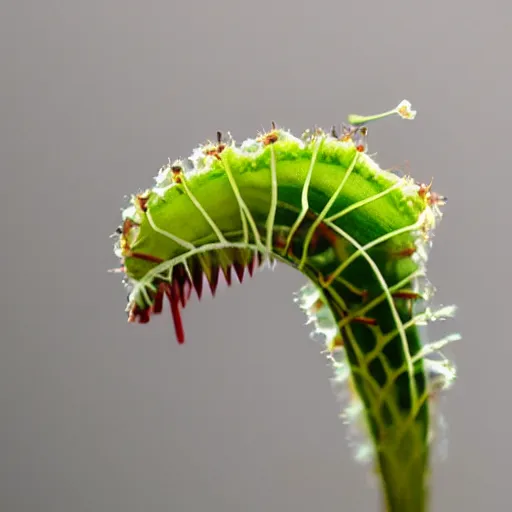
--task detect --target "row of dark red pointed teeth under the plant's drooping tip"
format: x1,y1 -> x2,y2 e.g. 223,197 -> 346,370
128,249 -> 264,344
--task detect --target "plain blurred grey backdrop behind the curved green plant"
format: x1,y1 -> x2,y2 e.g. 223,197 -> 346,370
0,0 -> 512,512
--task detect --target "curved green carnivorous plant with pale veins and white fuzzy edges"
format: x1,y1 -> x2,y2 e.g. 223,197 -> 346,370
111,100 -> 457,512
